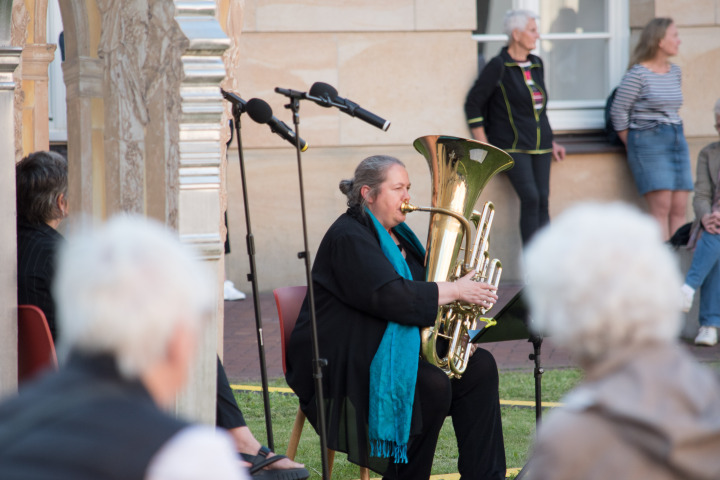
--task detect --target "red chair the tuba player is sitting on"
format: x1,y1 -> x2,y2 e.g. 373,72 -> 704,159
273,286 -> 370,480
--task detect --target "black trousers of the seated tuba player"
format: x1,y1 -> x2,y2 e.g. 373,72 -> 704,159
383,348 -> 506,480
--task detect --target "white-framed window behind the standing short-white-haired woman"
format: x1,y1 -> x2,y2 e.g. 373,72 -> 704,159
473,0 -> 630,132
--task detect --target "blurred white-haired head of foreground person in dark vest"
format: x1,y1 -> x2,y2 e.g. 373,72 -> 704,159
53,215 -> 215,379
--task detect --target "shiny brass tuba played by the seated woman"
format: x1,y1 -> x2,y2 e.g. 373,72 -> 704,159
402,135 -> 514,378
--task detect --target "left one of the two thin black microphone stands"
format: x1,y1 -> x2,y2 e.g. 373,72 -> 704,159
232,102 -> 275,451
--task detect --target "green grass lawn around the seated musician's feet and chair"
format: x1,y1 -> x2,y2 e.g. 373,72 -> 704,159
235,369 -> 581,480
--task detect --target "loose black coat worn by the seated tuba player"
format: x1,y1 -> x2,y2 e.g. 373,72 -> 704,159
286,209 -> 438,471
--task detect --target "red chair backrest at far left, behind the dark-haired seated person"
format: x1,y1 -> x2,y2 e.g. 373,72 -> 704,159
18,305 -> 57,383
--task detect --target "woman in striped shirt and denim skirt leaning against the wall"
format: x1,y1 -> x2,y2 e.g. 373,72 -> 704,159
611,18 -> 693,240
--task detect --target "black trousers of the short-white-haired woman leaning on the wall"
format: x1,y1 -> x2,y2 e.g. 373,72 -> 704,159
506,153 -> 552,245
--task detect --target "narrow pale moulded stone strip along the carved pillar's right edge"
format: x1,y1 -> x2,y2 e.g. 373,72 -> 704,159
175,0 -> 229,423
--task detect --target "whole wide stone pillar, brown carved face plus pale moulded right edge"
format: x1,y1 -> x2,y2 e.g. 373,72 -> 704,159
58,0 -> 227,423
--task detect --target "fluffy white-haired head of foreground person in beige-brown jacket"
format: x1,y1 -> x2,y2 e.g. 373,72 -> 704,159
525,203 -> 682,367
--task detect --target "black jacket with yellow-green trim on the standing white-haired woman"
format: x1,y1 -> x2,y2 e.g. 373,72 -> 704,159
465,47 -> 553,154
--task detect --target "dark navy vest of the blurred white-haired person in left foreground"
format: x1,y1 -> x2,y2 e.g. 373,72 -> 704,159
0,354 -> 188,480
